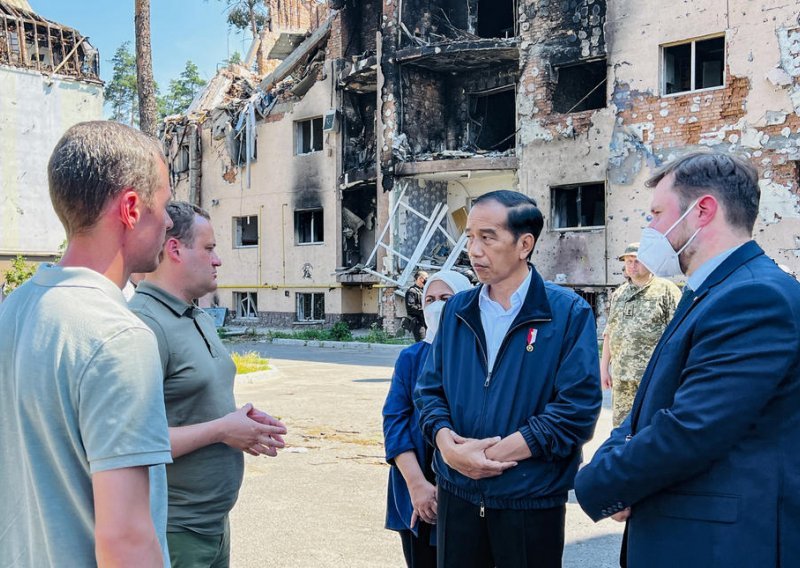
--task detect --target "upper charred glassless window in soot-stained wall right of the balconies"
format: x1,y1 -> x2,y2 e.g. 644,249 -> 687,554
553,59 -> 608,113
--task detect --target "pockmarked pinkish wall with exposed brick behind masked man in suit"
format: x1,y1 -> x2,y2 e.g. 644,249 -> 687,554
607,0 -> 800,271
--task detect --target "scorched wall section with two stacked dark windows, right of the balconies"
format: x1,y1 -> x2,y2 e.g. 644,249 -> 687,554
517,0 -> 614,285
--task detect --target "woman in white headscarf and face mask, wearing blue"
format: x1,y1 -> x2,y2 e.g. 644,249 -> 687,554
383,270 -> 472,568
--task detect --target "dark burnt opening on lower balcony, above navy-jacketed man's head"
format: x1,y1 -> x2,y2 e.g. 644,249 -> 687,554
469,88 -> 517,152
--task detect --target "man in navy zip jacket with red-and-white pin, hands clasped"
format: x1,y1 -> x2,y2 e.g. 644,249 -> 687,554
415,191 -> 602,568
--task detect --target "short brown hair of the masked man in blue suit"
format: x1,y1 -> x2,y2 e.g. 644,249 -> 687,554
645,152 -> 761,234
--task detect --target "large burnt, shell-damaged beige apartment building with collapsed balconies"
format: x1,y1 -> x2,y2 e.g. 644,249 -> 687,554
165,0 -> 800,331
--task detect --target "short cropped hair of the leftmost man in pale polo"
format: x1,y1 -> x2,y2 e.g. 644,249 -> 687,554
47,121 -> 166,237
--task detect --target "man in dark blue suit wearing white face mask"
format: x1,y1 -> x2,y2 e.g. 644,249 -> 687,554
575,153 -> 800,568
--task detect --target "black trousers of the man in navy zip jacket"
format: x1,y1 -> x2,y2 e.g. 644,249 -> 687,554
436,488 -> 566,568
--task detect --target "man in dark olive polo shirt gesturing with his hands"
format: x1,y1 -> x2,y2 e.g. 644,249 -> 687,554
130,202 -> 286,568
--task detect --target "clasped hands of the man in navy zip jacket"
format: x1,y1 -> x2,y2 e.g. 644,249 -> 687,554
436,428 -> 531,479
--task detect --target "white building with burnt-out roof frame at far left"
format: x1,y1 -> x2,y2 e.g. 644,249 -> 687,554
0,0 -> 103,285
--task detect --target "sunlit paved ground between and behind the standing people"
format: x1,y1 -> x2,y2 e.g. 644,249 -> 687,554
225,343 -> 622,568
